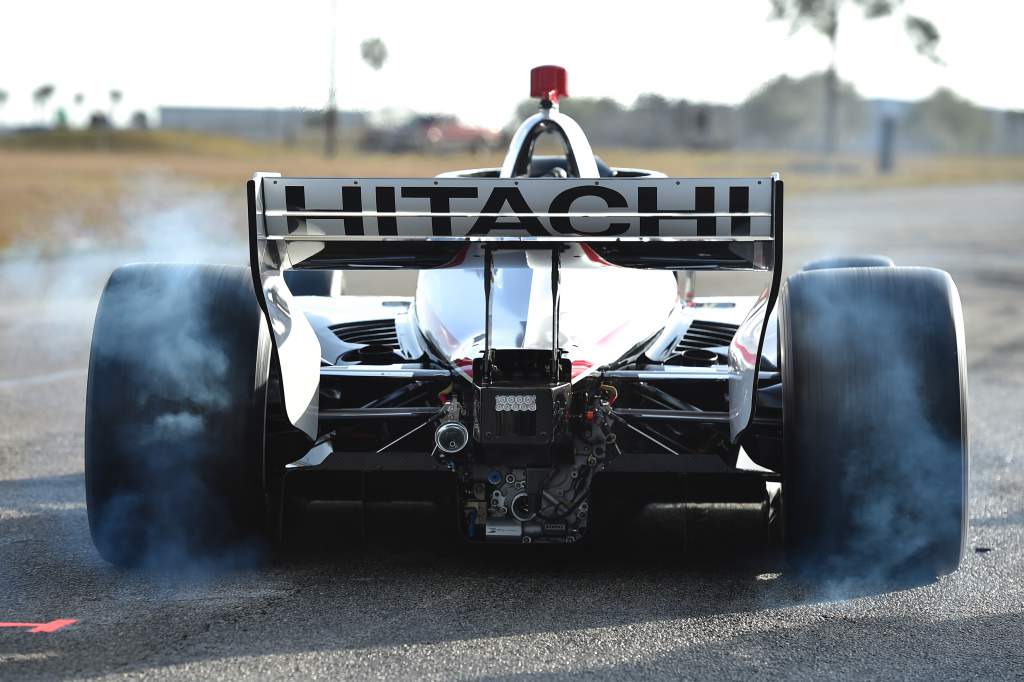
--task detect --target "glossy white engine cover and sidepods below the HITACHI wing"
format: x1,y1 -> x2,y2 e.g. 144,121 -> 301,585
295,280 -> 761,380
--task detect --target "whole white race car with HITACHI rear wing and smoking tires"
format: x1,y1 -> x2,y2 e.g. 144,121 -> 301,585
85,67 -> 968,576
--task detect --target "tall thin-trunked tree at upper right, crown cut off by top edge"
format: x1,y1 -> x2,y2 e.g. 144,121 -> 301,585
770,0 -> 940,155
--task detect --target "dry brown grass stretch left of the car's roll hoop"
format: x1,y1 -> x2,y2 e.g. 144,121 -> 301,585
0,133 -> 501,251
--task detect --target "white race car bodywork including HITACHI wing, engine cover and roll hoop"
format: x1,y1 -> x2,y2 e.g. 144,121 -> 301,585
249,90 -> 781,439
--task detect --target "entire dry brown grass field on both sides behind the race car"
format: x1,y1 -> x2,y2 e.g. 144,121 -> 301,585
0,132 -> 1024,250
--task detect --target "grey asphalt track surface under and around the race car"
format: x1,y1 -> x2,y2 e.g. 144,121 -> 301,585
0,185 -> 1024,680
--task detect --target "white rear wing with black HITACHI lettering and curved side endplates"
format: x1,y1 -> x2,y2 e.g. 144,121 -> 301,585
248,173 -> 782,437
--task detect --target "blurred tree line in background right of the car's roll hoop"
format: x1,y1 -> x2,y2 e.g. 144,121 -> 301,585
515,73 -> 1012,154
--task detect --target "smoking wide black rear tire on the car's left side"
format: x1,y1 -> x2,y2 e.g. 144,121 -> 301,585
85,264 -> 271,566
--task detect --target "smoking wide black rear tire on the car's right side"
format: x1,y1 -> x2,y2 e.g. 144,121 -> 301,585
779,267 -> 968,581
